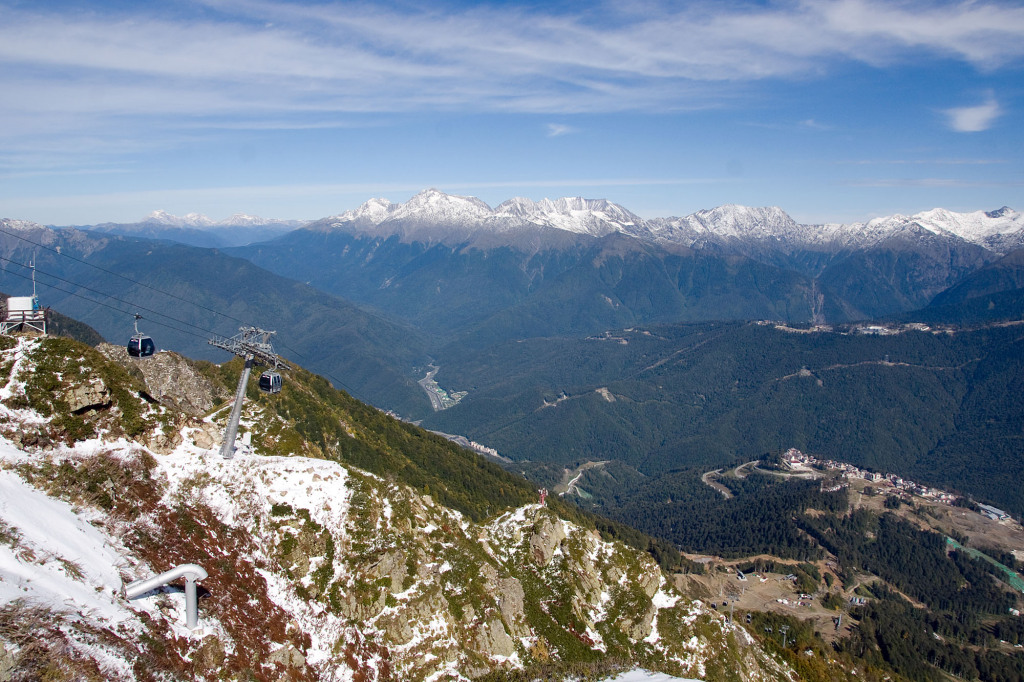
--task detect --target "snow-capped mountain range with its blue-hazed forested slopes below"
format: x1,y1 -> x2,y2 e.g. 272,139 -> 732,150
220,189 -> 1024,347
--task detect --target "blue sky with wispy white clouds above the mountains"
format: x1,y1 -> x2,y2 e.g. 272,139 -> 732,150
0,0 -> 1024,224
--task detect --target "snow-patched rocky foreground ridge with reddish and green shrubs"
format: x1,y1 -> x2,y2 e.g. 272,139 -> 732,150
0,331 -> 792,680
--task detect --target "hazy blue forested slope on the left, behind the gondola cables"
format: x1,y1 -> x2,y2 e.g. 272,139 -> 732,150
0,221 -> 429,415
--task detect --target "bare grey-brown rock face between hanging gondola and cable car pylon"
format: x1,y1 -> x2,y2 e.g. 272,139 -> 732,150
96,343 -> 226,417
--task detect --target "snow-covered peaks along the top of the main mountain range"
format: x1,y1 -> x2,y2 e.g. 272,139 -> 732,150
309,189 -> 1024,252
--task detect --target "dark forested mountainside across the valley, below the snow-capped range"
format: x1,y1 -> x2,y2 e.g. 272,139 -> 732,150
426,323 -> 1024,511
